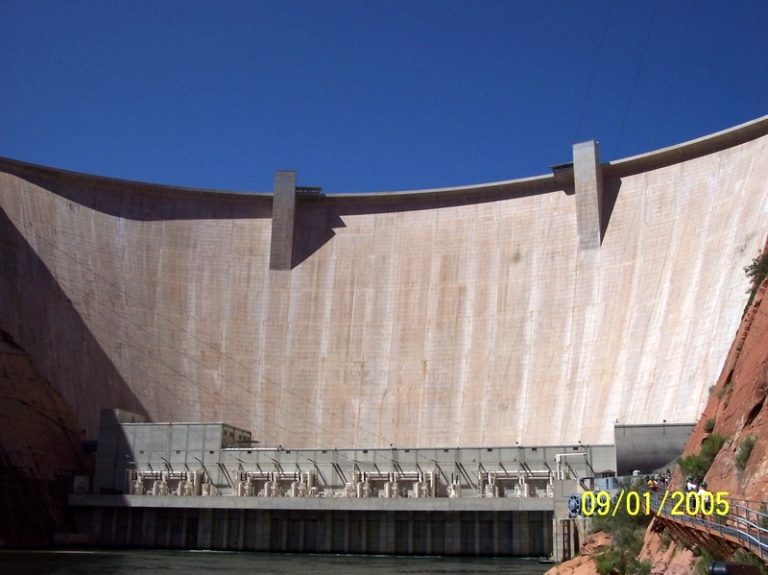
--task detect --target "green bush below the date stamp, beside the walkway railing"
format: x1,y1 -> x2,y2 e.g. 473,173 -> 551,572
592,488 -> 651,575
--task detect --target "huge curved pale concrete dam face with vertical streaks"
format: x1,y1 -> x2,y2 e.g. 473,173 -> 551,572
0,118 -> 768,447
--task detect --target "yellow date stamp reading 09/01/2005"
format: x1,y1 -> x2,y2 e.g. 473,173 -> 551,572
581,489 -> 731,517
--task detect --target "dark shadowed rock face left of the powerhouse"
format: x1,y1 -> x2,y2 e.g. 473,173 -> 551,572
0,331 -> 88,547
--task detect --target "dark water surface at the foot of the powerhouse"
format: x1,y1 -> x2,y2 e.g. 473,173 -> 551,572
0,551 -> 551,575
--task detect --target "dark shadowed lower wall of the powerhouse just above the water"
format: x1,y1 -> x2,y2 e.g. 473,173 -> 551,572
82,507 -> 552,557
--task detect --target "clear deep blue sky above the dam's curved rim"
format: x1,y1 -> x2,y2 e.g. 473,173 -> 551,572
0,0 -> 768,193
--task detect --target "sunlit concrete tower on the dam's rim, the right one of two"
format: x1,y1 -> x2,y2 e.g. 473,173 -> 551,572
573,140 -> 603,250
